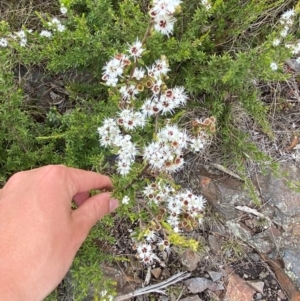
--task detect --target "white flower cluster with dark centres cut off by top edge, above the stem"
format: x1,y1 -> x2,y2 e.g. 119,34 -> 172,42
149,0 -> 182,36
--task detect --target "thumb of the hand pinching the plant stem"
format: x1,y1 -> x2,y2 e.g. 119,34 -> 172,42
72,192 -> 118,244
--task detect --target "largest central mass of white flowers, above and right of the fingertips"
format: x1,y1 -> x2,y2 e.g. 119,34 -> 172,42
98,39 -> 215,175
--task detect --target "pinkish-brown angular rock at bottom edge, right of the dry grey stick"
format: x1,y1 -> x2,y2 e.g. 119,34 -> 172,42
224,274 -> 255,301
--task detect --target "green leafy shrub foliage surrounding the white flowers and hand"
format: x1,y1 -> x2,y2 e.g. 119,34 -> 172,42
0,0 -> 299,300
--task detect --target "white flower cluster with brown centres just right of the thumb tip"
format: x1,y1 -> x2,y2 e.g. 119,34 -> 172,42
144,182 -> 205,232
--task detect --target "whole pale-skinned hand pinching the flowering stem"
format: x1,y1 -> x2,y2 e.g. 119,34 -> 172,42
0,165 -> 118,301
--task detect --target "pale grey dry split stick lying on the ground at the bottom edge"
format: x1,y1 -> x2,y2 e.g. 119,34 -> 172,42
115,272 -> 191,301
